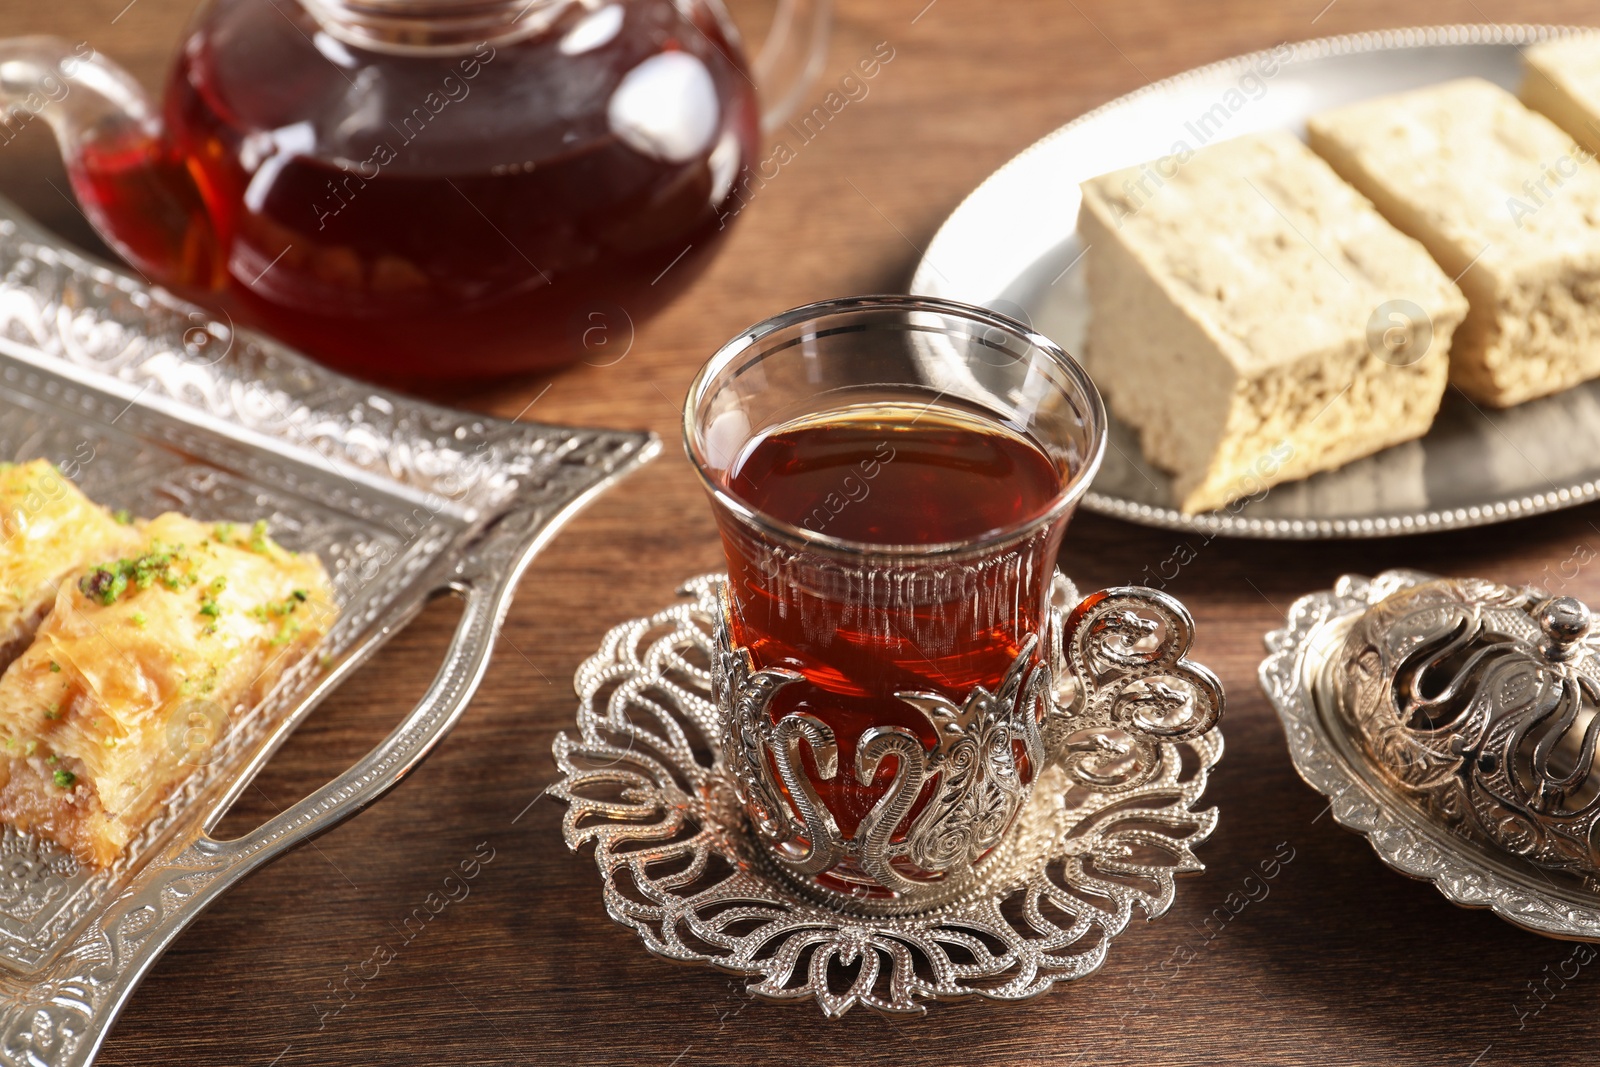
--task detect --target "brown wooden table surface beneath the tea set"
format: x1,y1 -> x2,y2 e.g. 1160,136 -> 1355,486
0,0 -> 1600,1067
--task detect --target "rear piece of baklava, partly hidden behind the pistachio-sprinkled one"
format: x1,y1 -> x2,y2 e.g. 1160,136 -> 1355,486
0,459 -> 138,669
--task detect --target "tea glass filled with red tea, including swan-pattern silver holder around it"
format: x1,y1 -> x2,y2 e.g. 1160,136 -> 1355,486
683,296 -> 1106,909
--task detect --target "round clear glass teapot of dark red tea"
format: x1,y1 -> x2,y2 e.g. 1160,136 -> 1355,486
0,0 -> 829,384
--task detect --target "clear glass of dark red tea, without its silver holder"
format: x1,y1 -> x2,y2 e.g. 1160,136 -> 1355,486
685,298 -> 1104,897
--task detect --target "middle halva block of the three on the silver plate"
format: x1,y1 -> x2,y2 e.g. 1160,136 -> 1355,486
1307,78 -> 1600,408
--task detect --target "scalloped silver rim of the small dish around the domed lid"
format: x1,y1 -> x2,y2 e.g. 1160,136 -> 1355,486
1261,571 -> 1600,941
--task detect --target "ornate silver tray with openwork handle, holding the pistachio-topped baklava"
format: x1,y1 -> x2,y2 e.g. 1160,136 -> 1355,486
0,200 -> 659,1067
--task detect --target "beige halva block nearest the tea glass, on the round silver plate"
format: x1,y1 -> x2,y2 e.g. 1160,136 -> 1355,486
1078,131 -> 1467,514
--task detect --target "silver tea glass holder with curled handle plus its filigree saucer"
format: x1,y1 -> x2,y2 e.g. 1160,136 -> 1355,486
550,574 -> 1222,1017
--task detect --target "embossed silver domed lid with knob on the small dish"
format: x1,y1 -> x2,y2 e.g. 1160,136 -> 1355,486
1328,577 -> 1600,881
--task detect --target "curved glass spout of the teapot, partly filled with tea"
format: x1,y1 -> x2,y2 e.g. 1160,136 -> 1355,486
0,37 -> 218,293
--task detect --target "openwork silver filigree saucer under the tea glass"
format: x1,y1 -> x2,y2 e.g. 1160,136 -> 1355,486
550,576 -> 1222,1017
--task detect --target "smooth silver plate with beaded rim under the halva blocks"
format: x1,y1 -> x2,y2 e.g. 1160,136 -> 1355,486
910,26 -> 1600,539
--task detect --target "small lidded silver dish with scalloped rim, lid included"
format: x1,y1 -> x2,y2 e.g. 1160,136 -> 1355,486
1261,571 -> 1600,941
